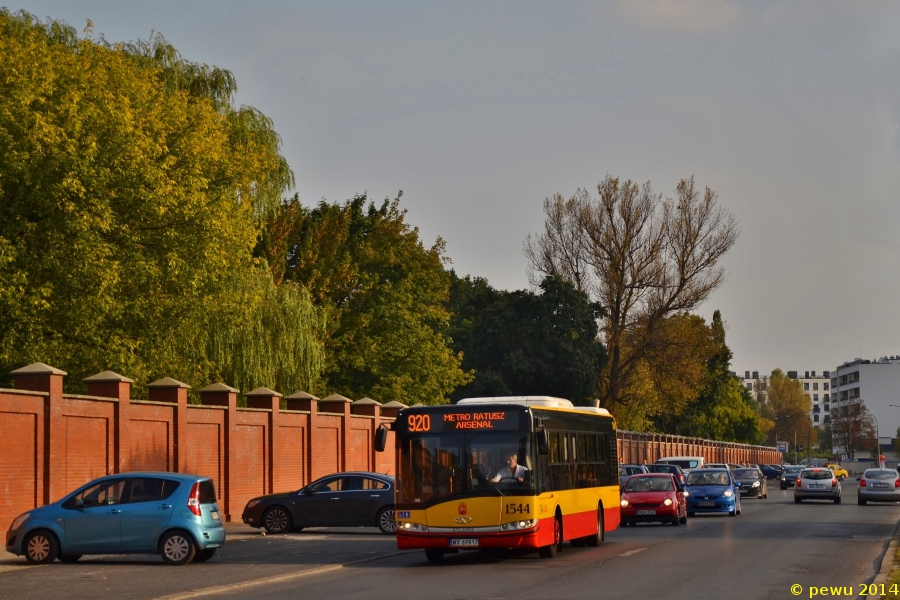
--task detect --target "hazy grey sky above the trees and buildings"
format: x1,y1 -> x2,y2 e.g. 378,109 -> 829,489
7,0 -> 900,372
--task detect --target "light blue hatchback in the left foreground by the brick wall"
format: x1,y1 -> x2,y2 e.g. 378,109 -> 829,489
6,473 -> 225,565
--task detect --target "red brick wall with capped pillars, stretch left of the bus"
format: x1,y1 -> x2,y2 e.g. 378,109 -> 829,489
0,363 -> 397,531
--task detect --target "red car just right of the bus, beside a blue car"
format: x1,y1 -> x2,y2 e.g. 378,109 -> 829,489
620,473 -> 687,526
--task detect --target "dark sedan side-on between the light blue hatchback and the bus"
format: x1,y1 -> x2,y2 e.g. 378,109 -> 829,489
242,471 -> 397,535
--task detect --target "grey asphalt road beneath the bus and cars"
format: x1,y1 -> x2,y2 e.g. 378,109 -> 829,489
0,481 -> 900,600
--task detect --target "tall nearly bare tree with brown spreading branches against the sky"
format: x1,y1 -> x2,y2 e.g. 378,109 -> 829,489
525,176 -> 738,406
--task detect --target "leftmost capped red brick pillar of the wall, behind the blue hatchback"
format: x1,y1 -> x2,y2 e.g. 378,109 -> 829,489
10,363 -> 68,504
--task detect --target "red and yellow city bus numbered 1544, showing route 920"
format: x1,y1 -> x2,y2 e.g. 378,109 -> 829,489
375,396 -> 619,562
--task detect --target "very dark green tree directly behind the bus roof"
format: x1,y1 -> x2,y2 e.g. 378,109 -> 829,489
450,273 -> 606,405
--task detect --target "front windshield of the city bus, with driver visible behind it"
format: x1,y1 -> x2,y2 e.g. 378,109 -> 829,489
397,432 -> 535,508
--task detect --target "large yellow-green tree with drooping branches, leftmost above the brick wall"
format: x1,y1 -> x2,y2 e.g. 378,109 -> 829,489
0,9 -> 321,396
